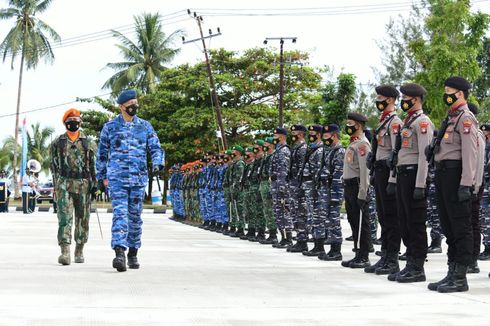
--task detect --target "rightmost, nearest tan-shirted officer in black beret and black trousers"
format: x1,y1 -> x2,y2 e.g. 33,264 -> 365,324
428,77 -> 478,293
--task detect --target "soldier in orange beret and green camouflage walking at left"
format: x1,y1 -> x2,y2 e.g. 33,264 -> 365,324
50,109 -> 97,265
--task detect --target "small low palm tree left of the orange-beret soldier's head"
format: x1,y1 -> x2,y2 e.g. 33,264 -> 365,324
27,123 -> 54,174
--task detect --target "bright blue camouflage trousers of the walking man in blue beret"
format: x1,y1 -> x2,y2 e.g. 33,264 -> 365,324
110,187 -> 145,248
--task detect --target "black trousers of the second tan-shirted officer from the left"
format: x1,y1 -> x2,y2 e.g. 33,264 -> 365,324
374,165 -> 401,254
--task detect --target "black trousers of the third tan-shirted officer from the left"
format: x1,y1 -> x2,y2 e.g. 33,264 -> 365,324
396,168 -> 427,259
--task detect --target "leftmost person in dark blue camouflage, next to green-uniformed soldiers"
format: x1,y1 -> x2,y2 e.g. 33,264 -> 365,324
269,128 -> 293,248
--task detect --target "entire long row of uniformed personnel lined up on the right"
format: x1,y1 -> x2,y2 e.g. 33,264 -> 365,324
171,77 -> 490,293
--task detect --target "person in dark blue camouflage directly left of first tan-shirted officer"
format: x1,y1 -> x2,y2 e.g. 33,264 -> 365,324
313,124 -> 345,261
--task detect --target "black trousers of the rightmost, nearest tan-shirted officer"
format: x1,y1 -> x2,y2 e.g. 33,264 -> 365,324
436,167 -> 473,265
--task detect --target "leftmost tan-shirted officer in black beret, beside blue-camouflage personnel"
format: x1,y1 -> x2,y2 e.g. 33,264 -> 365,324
342,113 -> 371,268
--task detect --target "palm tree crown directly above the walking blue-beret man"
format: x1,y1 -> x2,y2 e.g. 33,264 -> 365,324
102,13 -> 182,94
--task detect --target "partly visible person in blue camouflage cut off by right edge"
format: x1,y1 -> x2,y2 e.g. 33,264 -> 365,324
478,123 -> 490,262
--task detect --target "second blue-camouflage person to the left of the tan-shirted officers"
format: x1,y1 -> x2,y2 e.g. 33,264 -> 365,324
298,125 -> 325,256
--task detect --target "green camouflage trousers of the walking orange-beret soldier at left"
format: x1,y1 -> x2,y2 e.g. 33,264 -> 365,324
56,181 -> 90,245
